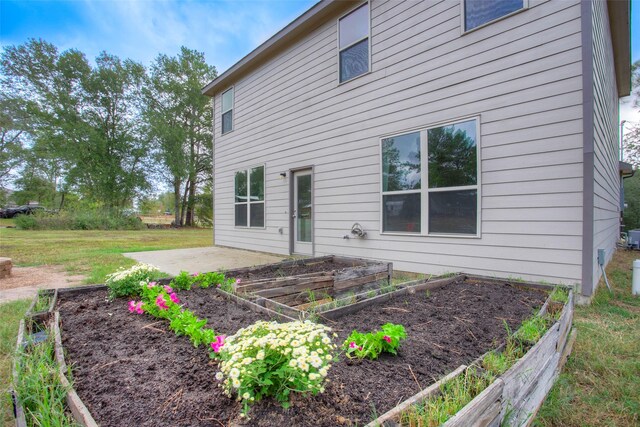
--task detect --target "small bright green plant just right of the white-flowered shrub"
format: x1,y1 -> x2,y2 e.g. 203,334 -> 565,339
342,323 -> 407,360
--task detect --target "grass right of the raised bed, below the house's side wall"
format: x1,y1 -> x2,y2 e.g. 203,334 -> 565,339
535,251 -> 640,427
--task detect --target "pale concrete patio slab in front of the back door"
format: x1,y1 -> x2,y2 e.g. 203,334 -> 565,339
123,246 -> 286,276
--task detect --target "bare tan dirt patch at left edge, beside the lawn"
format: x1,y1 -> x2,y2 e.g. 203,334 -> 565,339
0,265 -> 84,304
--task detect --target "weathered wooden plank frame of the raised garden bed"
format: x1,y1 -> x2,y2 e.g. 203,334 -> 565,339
14,266 -> 576,427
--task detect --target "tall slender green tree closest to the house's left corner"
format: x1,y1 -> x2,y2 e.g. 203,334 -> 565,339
144,47 -> 216,225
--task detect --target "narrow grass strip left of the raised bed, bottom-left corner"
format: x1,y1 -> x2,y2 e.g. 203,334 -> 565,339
0,300 -> 31,426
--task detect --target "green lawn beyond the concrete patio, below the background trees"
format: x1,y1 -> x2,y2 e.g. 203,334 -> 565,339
0,228 -> 212,283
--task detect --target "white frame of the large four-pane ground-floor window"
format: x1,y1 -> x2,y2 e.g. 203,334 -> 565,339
378,115 -> 482,239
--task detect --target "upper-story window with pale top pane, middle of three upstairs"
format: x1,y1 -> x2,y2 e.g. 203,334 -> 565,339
338,3 -> 370,83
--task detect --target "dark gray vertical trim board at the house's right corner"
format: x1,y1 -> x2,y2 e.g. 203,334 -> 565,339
580,0 -> 594,298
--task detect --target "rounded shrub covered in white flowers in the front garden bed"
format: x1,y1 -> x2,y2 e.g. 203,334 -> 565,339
211,321 -> 336,415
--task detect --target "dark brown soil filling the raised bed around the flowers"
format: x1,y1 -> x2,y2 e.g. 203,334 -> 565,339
60,281 -> 545,426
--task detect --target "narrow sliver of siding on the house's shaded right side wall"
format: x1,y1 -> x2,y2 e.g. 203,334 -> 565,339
592,2 -> 620,289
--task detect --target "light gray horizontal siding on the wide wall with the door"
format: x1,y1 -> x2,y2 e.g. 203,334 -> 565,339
215,0 -> 582,283
